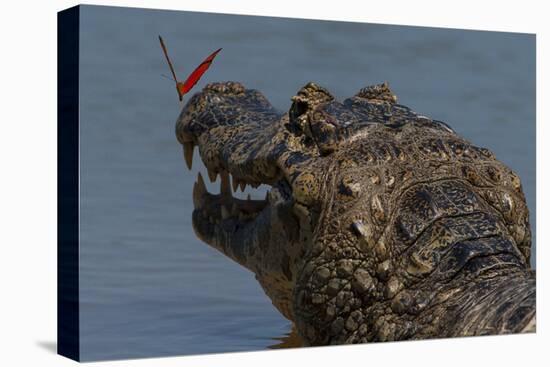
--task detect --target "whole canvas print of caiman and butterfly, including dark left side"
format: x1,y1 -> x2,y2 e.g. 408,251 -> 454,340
58,6 -> 536,361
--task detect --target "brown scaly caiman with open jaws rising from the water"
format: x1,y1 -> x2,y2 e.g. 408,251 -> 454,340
176,82 -> 535,345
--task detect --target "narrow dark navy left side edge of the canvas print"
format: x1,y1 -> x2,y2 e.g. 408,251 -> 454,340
57,6 -> 80,361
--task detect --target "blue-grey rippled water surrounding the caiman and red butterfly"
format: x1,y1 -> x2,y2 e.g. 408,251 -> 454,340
80,6 -> 535,360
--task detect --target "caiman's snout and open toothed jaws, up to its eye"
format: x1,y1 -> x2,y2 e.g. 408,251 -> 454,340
176,82 -> 329,320
